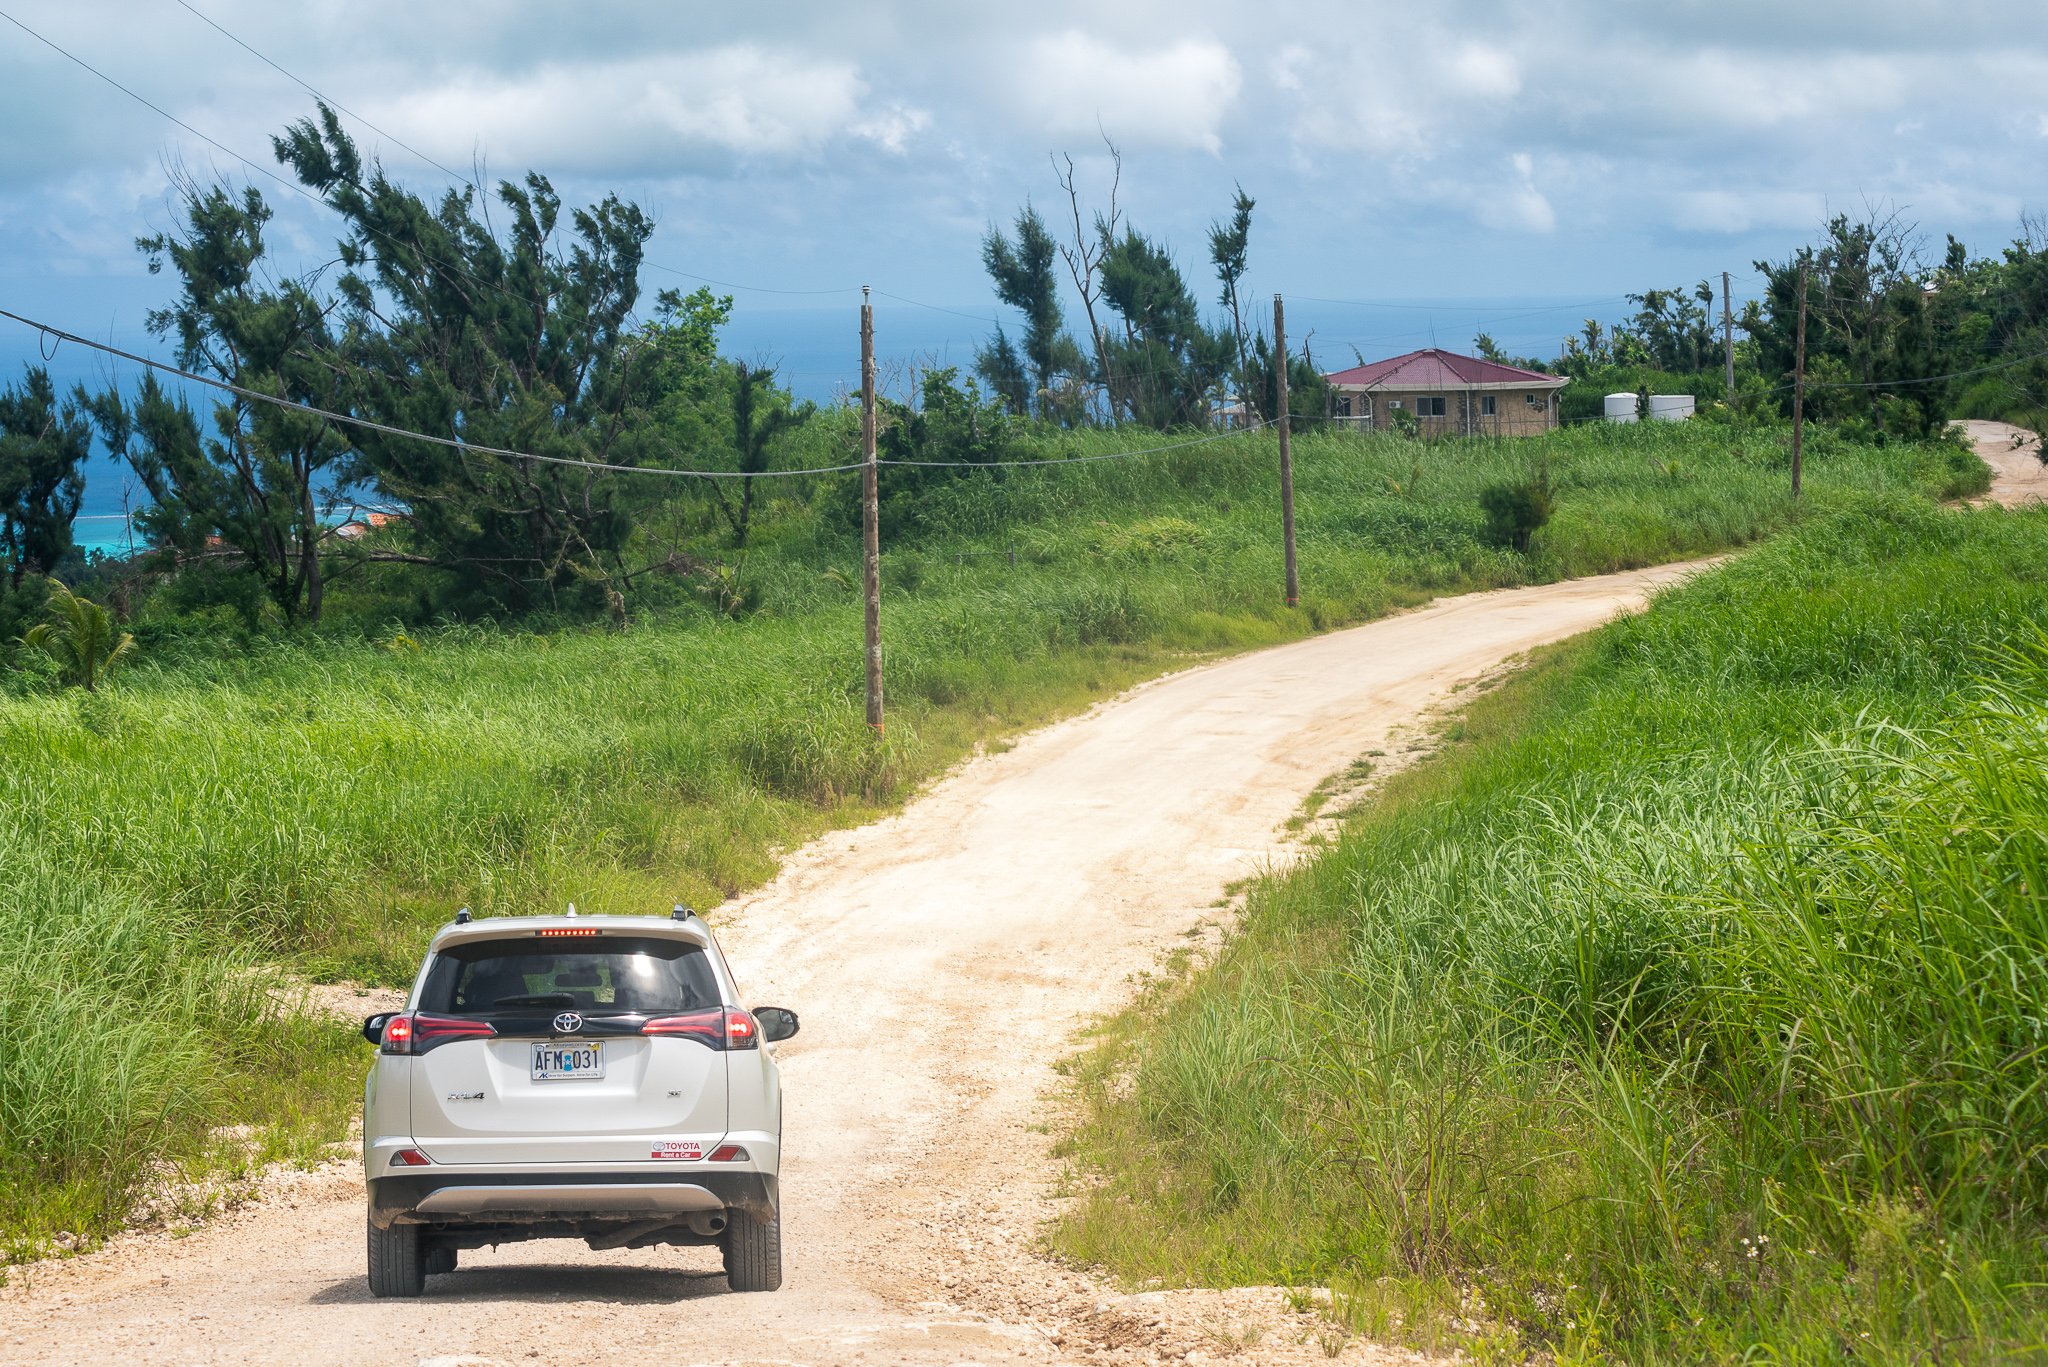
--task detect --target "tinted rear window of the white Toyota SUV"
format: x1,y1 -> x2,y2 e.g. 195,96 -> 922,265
420,935 -> 719,1017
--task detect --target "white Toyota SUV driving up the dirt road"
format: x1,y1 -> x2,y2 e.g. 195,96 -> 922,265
362,906 -> 797,1295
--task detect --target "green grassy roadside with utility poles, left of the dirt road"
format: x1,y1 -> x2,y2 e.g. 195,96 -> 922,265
0,428 -> 1968,1254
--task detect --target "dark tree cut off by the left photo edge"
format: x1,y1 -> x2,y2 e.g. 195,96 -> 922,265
0,367 -> 92,586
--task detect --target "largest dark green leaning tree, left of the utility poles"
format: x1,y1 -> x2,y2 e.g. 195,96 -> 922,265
272,105 -> 678,607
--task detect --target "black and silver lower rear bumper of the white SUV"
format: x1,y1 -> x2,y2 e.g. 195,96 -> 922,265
369,1168 -> 780,1230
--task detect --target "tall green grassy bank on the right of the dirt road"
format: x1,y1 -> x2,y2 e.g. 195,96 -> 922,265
1055,500 -> 2048,1363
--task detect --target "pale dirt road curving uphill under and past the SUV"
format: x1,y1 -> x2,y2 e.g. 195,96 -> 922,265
0,566 -> 1712,1367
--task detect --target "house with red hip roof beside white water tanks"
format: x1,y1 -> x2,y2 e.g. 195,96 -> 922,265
1325,346 -> 1571,437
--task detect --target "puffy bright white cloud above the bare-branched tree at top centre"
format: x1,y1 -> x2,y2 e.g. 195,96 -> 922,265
1014,31 -> 1243,154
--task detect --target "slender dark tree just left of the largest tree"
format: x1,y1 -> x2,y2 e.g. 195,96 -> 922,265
80,184 -> 348,621
